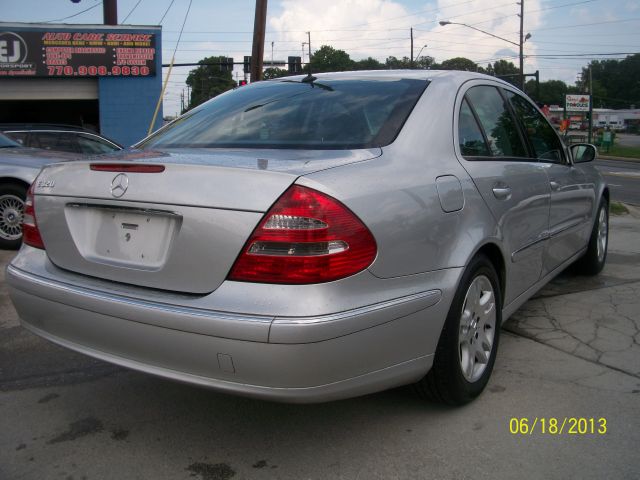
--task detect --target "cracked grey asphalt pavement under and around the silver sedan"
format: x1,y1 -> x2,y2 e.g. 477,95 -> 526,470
0,207 -> 640,480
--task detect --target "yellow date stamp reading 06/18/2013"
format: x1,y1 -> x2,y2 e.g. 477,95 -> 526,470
509,417 -> 608,435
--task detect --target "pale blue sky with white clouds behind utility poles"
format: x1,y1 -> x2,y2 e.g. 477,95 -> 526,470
0,0 -> 640,115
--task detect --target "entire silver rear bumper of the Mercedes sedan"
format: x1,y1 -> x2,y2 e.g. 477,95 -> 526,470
7,253 -> 456,402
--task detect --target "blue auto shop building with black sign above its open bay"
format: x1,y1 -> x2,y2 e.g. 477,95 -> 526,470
0,23 -> 162,145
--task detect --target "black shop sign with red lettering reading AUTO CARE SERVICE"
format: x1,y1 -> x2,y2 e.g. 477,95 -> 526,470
0,26 -> 156,78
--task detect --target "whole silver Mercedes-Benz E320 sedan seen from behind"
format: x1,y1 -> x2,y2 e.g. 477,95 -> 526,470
7,71 -> 609,404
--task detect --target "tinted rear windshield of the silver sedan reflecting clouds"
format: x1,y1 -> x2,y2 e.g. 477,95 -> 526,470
137,79 -> 427,149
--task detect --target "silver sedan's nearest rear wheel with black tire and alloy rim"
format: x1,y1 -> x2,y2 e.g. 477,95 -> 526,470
415,255 -> 502,405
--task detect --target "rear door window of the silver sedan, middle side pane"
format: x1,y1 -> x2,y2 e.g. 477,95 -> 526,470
465,86 -> 528,158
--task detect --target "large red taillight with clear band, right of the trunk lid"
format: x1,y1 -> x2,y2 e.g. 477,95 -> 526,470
229,185 -> 377,284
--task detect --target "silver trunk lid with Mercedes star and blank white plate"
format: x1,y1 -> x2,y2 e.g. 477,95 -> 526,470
34,148 -> 375,294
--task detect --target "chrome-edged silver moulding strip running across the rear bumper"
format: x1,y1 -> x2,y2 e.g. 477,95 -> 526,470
7,265 -> 442,343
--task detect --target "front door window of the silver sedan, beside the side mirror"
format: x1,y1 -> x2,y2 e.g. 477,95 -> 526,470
505,91 -> 564,162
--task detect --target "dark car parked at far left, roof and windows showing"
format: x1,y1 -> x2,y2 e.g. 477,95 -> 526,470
0,124 -> 122,155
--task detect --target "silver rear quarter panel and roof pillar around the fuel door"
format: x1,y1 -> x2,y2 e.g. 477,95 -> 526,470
298,73 -> 499,278
